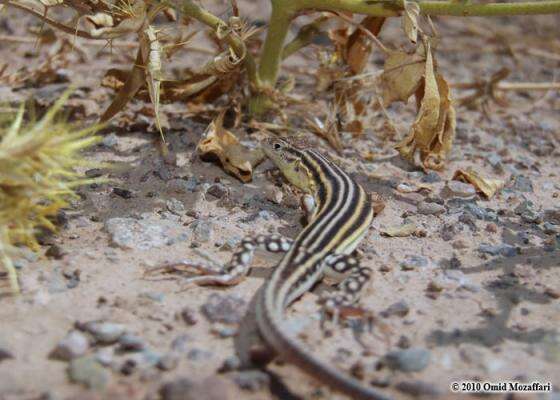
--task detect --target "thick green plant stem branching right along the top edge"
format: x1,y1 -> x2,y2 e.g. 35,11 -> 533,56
249,0 -> 560,115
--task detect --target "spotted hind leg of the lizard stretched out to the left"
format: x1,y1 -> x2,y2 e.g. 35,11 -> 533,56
148,235 -> 292,286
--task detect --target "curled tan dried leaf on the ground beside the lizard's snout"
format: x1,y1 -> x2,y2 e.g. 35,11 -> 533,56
197,112 -> 264,182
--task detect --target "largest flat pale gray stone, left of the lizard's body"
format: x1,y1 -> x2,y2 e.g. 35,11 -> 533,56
105,217 -> 183,250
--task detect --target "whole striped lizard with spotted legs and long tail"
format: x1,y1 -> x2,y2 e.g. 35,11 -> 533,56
172,138 -> 388,400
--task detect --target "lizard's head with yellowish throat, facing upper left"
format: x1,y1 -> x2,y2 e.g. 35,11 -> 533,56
261,138 -> 313,192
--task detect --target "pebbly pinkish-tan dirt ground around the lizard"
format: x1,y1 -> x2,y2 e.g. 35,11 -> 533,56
0,2 -> 560,400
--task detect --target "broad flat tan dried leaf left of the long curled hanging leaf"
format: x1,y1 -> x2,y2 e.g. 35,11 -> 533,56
380,46 -> 426,106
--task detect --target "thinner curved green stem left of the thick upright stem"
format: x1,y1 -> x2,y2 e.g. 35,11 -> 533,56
182,0 -> 260,87
